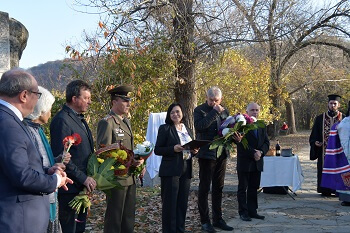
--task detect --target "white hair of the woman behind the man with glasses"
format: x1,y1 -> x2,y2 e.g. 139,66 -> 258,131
27,86 -> 55,120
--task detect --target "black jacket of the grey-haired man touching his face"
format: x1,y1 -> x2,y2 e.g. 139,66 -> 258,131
193,102 -> 229,160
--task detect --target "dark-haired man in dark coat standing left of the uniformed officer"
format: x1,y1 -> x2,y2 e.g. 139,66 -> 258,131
50,80 -> 96,233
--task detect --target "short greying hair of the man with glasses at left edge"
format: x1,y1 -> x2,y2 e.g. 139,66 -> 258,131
0,68 -> 33,97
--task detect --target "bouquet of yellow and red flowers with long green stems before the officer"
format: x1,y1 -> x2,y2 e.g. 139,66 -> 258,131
69,143 -> 133,214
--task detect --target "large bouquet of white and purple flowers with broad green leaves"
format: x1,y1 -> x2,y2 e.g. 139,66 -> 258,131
209,113 -> 265,156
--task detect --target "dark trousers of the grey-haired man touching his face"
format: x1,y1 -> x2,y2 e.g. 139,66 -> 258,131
198,155 -> 227,224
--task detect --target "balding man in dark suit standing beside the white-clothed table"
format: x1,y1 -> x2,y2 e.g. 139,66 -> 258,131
234,103 -> 270,221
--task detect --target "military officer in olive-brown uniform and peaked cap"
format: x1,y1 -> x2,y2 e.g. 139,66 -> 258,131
97,85 -> 144,233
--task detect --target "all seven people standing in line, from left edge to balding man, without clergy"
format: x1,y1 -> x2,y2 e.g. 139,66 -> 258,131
0,68 -> 269,233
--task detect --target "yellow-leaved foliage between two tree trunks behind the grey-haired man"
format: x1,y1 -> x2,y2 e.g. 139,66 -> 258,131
197,50 -> 272,121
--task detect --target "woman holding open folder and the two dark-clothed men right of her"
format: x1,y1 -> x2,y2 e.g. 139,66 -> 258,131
154,86 -> 270,233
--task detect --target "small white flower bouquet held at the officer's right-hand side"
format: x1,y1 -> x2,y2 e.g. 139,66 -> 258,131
131,141 -> 154,186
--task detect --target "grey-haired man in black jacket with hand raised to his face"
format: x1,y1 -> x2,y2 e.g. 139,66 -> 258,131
194,86 -> 233,233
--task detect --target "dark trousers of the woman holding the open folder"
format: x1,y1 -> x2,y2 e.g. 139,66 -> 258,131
161,160 -> 191,233
